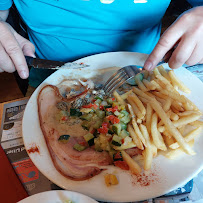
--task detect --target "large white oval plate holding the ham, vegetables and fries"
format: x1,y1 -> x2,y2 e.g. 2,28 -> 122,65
23,52 -> 203,202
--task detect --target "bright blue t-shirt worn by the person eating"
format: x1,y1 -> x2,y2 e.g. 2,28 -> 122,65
0,0 -> 202,87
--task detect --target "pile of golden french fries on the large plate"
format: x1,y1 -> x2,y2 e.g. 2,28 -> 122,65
114,66 -> 203,174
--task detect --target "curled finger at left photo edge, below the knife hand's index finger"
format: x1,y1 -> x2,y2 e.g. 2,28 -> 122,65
0,43 -> 15,73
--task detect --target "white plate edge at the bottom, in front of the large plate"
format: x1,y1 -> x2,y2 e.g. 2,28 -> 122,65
18,190 -> 98,203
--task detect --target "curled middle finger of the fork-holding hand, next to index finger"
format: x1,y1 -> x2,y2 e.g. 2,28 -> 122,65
168,35 -> 196,69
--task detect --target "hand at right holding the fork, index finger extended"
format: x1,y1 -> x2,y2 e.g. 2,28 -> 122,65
144,6 -> 203,70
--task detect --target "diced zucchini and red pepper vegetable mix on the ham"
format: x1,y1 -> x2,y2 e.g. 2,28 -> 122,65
58,92 -> 134,170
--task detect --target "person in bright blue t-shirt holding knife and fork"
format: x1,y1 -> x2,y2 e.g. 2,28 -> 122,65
0,0 -> 203,87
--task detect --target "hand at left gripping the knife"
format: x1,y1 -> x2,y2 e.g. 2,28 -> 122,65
0,20 -> 35,79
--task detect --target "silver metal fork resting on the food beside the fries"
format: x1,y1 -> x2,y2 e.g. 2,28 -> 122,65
102,61 -> 166,94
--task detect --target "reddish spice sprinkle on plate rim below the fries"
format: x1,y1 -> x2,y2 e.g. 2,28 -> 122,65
132,172 -> 158,187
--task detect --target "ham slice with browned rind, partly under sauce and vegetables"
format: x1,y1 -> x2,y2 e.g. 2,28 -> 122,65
38,85 -> 112,180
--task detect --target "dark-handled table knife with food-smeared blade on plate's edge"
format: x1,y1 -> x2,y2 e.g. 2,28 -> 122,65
25,56 -> 89,70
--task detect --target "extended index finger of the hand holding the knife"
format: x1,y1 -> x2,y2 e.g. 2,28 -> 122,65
1,23 -> 29,79
